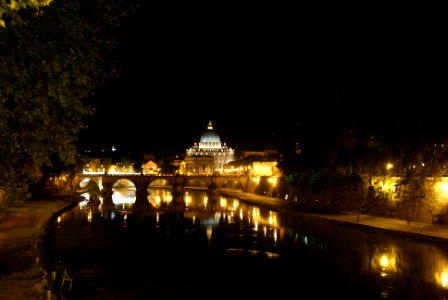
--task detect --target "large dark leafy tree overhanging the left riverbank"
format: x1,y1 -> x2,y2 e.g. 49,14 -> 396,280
0,0 -> 135,204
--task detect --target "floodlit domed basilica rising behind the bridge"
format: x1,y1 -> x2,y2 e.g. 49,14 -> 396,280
181,121 -> 235,175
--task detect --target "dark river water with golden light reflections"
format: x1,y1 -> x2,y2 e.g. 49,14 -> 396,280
46,191 -> 448,300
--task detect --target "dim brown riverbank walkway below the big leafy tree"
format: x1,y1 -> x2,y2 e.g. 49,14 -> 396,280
0,198 -> 74,300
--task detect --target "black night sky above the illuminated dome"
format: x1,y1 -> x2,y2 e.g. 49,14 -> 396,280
77,6 -> 446,159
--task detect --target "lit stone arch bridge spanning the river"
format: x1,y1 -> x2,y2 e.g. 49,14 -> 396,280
71,174 -> 253,209
